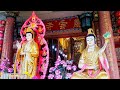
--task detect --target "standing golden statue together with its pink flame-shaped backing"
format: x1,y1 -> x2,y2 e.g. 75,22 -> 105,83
14,11 -> 49,79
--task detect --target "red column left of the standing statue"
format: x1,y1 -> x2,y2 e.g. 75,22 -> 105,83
1,16 -> 15,64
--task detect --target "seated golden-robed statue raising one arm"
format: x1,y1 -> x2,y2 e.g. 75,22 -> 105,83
71,28 -> 110,79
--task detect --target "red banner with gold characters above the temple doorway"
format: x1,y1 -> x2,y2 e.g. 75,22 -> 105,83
43,17 -> 80,30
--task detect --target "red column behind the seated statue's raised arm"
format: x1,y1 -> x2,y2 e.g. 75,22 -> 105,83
98,11 -> 119,79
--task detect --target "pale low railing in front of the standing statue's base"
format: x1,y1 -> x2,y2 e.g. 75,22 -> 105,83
0,73 -> 29,79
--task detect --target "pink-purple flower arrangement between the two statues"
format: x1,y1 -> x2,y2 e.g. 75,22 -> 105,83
48,57 -> 77,79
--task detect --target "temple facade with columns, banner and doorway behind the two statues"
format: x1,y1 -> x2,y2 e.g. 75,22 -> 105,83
0,11 -> 120,79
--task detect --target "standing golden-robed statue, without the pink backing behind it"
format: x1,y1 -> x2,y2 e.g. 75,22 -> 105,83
16,28 -> 39,77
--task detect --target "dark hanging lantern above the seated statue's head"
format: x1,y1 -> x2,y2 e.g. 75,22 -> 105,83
79,12 -> 93,32
